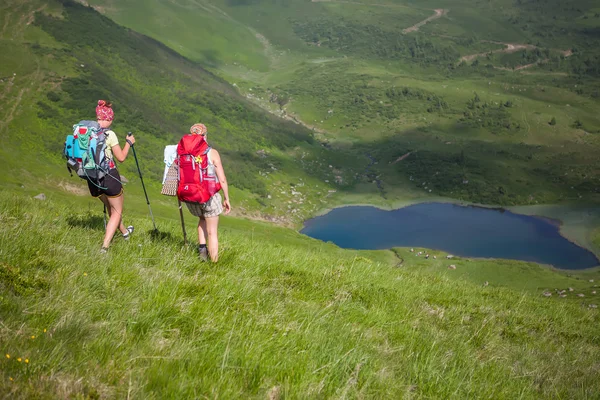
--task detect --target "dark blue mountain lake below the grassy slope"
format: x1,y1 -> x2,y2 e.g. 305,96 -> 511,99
301,203 -> 600,269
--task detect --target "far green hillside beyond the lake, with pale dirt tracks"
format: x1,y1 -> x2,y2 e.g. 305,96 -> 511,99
89,0 -> 600,209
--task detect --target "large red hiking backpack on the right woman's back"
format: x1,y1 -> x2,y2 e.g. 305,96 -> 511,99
176,135 -> 221,203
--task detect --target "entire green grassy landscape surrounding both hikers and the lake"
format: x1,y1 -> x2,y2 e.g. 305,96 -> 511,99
0,0 -> 600,399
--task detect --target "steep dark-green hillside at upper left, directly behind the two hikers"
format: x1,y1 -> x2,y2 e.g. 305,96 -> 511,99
0,1 -> 356,223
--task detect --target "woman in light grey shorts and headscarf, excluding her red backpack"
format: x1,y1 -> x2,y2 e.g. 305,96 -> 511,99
185,124 -> 231,262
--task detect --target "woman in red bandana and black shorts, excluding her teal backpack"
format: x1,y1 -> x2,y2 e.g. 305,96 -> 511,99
87,100 -> 135,253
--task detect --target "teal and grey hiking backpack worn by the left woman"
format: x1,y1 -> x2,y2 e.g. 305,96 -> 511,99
63,121 -> 110,187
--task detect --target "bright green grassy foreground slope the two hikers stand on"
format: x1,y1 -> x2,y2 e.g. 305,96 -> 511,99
0,192 -> 600,399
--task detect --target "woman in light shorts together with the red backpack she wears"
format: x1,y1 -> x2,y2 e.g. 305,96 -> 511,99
177,124 -> 231,262
